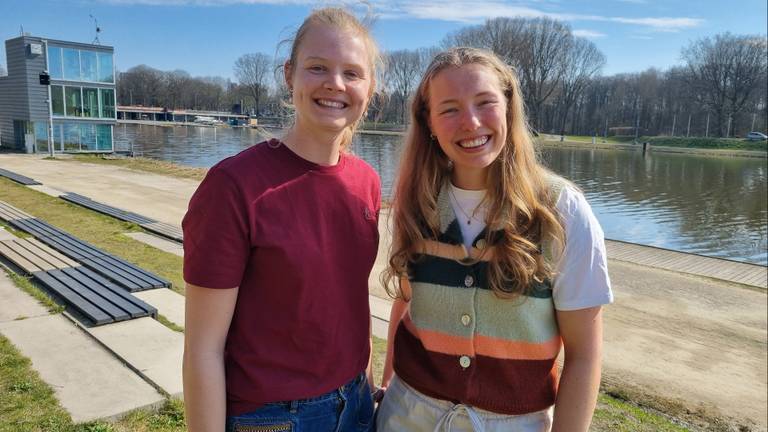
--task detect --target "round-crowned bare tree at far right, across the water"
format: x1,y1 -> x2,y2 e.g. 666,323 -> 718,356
682,33 -> 768,136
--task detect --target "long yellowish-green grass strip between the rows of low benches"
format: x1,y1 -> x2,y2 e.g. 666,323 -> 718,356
0,178 -> 184,293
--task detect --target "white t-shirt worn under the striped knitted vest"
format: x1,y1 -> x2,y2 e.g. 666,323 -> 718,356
450,185 -> 613,311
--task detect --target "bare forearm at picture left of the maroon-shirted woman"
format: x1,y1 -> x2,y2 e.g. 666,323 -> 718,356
183,351 -> 227,432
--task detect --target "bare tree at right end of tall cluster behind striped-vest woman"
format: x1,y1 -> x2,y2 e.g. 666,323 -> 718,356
560,38 -> 605,134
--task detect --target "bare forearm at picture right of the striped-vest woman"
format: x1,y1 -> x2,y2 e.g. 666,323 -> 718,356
552,353 -> 600,432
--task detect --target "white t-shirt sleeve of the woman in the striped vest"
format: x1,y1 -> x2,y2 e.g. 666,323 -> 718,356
553,186 -> 613,311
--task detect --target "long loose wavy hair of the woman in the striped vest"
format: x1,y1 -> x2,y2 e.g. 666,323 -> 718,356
382,48 -> 565,298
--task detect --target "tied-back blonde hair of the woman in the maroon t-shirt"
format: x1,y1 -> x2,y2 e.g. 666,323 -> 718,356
278,7 -> 383,150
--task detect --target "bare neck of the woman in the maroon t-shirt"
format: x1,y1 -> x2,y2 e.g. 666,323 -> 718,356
282,119 -> 343,166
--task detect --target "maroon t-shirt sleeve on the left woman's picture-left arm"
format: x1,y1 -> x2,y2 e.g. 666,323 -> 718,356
182,167 -> 250,288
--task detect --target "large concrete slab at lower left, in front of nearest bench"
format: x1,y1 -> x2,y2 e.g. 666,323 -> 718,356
0,312 -> 164,423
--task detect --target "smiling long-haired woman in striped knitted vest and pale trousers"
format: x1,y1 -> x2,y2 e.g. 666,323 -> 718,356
377,48 -> 613,432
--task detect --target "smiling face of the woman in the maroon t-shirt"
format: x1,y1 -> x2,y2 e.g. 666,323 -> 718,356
286,24 -> 373,134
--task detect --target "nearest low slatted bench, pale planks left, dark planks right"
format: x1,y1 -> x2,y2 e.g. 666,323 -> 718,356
0,239 -> 157,325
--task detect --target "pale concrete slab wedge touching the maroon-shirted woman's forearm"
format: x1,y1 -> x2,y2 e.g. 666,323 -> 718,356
85,317 -> 184,397
